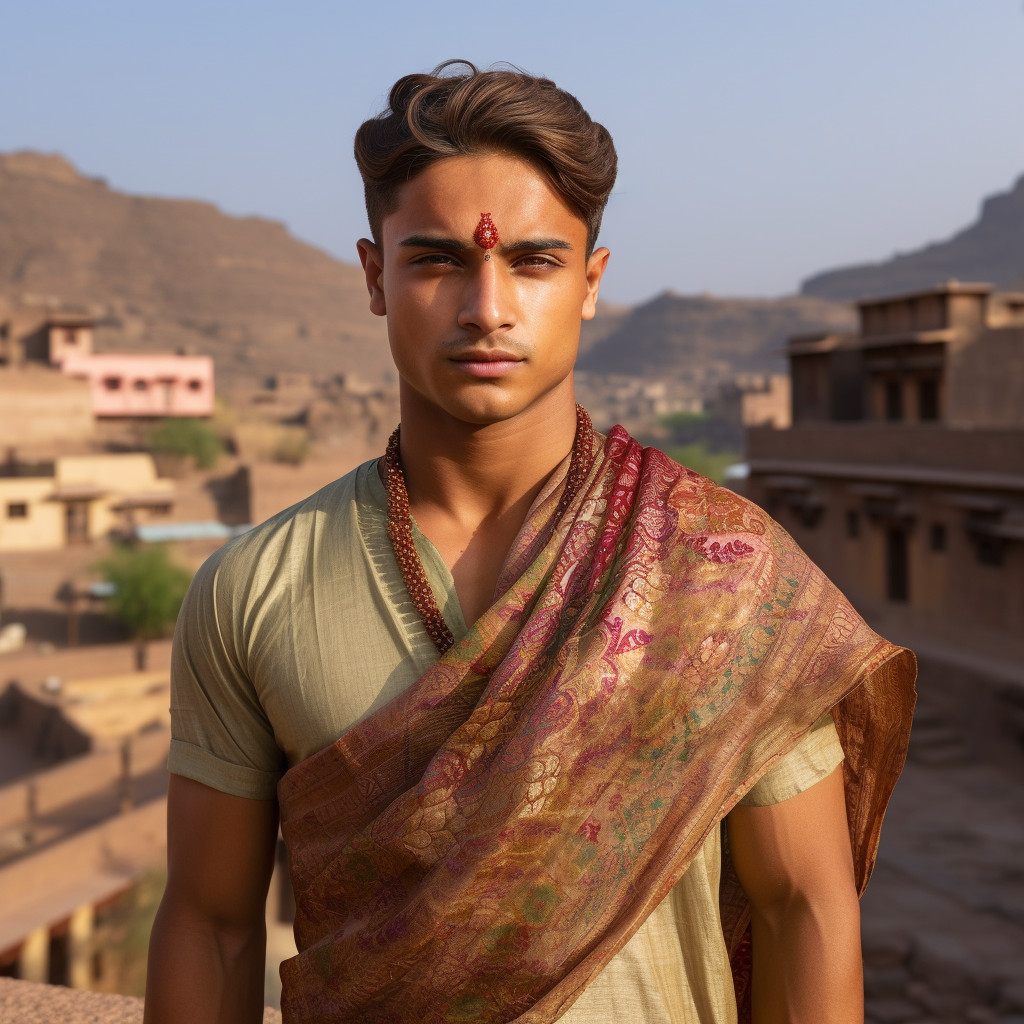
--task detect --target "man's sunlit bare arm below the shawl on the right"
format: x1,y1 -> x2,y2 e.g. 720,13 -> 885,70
728,768 -> 864,1024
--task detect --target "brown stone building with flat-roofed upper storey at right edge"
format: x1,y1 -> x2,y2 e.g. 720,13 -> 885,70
746,282 -> 1024,659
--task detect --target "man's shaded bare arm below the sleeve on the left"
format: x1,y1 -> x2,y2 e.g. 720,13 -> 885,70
145,775 -> 278,1024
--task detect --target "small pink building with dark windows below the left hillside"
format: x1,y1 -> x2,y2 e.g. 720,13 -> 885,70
60,348 -> 213,417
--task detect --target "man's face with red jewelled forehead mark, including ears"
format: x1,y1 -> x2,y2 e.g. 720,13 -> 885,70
358,154 -> 608,424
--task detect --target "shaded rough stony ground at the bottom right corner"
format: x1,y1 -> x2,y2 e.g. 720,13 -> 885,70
861,660 -> 1024,1024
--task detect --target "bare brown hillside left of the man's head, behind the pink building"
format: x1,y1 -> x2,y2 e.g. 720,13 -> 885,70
0,153 -> 390,381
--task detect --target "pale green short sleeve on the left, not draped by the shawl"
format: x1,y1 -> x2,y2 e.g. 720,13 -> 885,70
168,549 -> 285,800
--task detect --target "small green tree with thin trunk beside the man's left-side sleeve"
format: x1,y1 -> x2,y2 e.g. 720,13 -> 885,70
95,546 -> 191,672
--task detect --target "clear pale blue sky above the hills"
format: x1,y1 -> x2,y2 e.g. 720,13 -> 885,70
0,0 -> 1024,302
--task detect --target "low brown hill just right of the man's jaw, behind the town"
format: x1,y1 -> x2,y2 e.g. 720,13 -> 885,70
580,292 -> 854,388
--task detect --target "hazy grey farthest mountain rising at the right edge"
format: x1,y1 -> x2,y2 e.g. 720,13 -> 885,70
801,175 -> 1024,299
